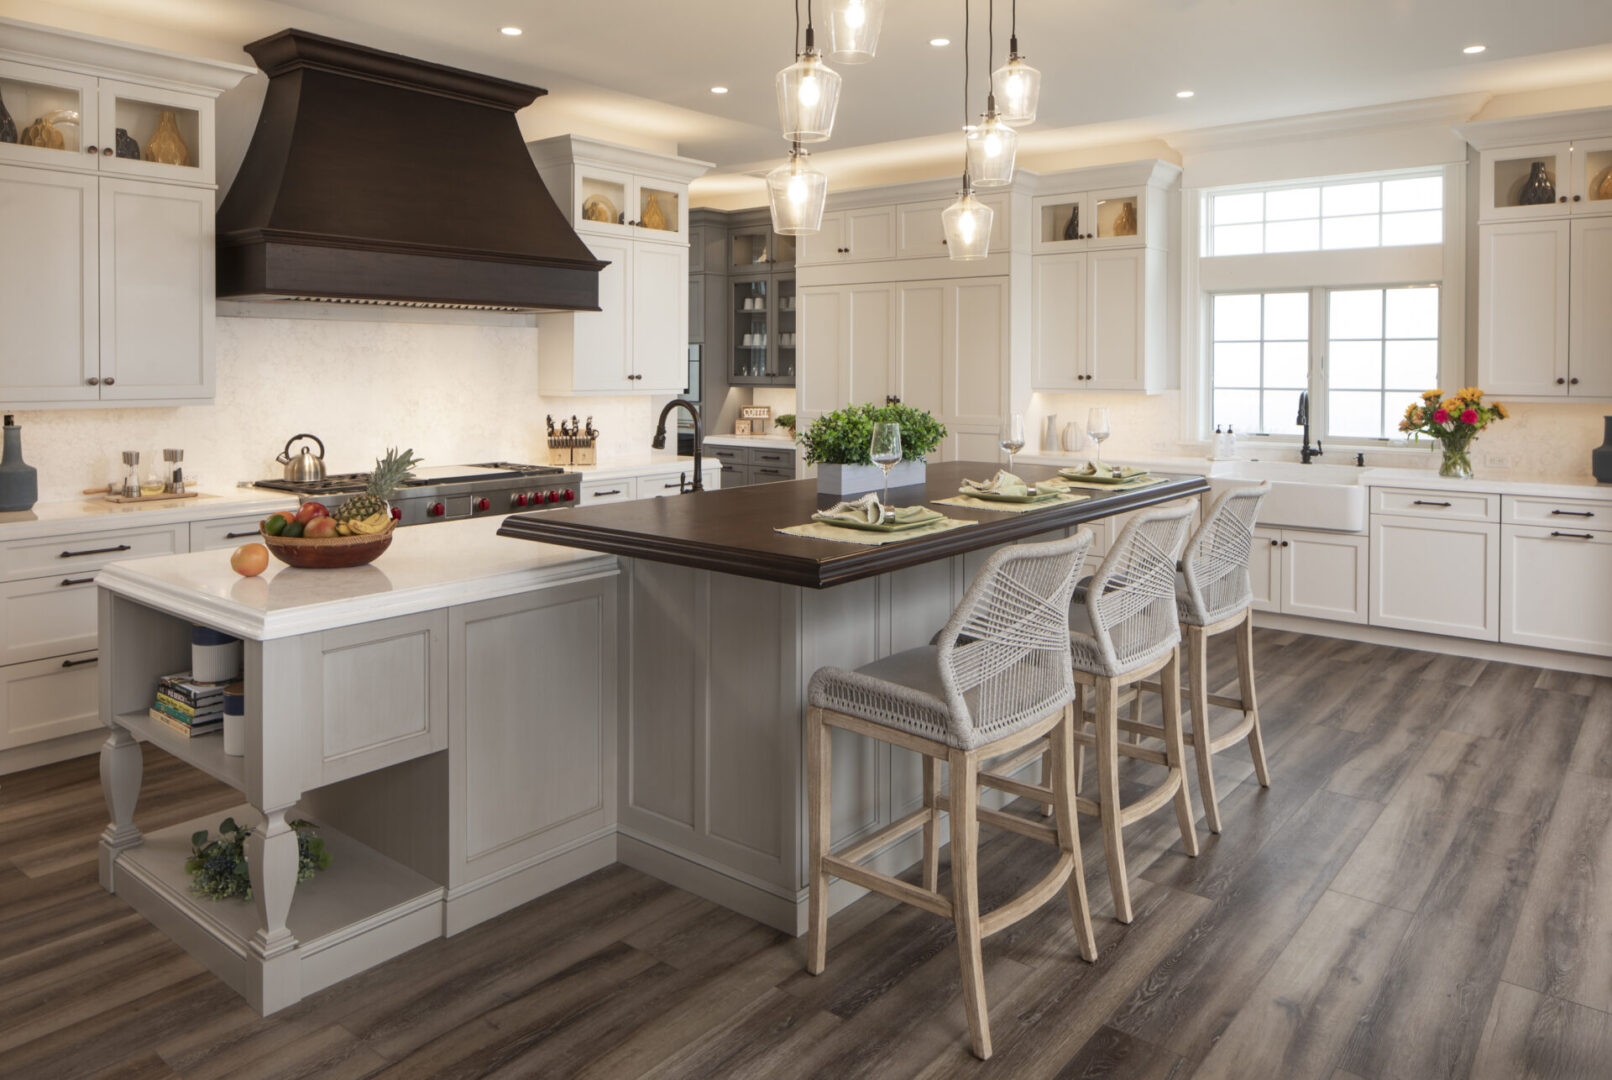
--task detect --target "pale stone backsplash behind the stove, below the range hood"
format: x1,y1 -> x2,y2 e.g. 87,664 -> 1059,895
6,318 -> 659,501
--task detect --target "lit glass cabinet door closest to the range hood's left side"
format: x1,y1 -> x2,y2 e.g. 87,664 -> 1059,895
98,81 -> 213,184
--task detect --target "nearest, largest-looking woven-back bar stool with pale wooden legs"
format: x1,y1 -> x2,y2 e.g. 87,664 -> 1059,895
806,529 -> 1096,1059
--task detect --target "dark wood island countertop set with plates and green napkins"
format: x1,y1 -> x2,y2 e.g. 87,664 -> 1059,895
498,461 -> 1209,588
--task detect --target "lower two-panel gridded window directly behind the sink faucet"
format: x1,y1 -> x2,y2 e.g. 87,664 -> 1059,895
1209,285 -> 1440,438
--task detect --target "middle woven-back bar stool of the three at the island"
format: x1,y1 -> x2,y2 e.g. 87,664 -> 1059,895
1043,506 -> 1198,922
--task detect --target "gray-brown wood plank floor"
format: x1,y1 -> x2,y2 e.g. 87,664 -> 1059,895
0,630 -> 1612,1080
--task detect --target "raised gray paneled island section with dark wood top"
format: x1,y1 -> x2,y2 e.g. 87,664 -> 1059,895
500,463 -> 1209,933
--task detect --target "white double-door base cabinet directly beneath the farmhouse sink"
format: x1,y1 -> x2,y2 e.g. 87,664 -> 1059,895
1249,529 -> 1370,622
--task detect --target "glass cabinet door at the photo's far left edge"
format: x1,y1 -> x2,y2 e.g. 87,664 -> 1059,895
0,61 -> 100,169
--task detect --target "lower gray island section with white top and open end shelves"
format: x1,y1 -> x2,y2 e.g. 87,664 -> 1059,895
97,521 -> 617,1014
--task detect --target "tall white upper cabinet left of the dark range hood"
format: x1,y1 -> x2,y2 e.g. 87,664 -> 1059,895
0,19 -> 251,408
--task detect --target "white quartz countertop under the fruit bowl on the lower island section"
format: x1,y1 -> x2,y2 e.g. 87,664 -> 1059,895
95,517 -> 617,642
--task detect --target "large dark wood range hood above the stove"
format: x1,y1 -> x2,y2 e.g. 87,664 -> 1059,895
218,31 -> 606,311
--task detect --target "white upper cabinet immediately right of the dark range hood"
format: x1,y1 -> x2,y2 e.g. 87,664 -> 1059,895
527,135 -> 711,395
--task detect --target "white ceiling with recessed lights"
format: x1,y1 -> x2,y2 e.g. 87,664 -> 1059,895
9,0 -> 1612,202
